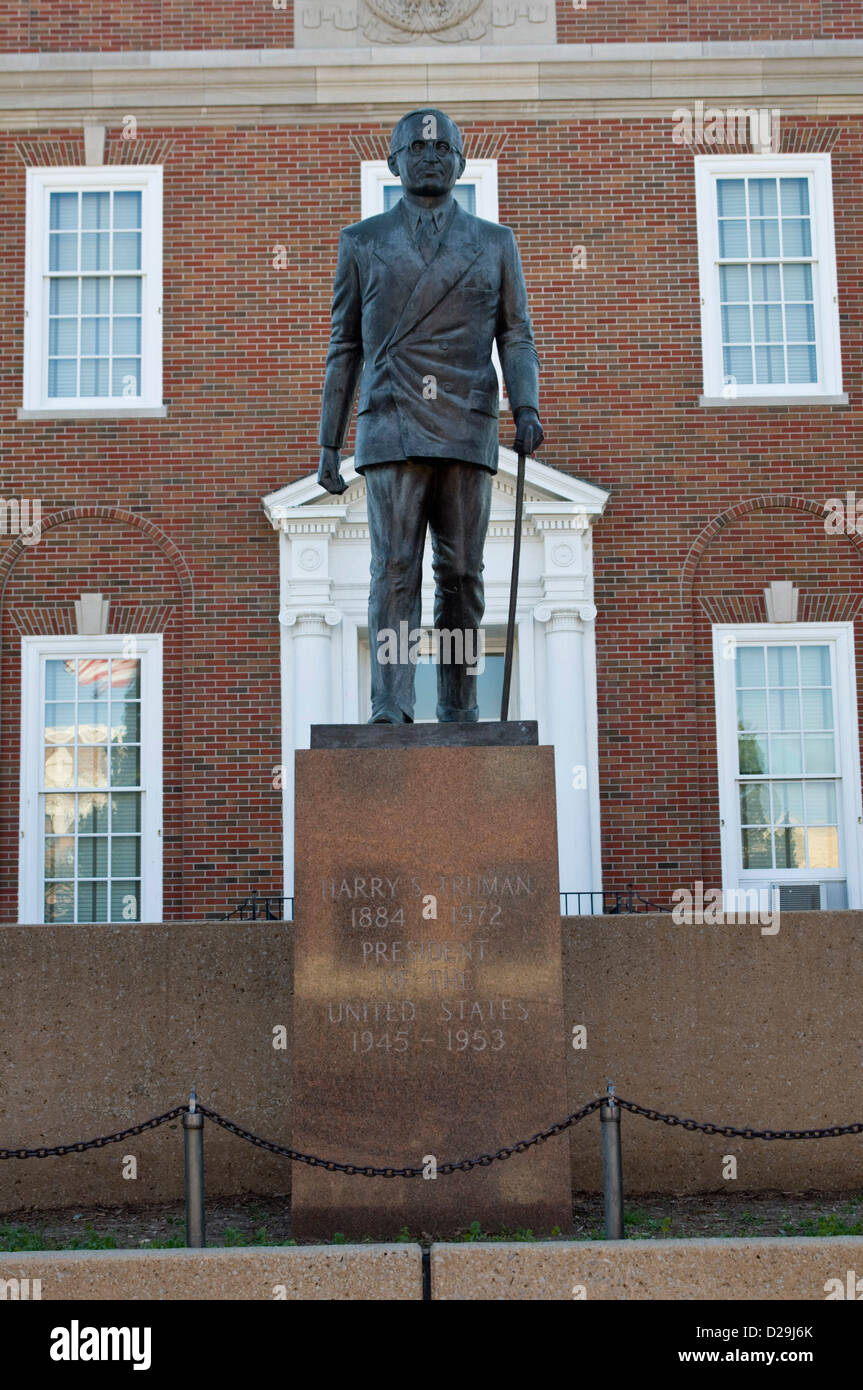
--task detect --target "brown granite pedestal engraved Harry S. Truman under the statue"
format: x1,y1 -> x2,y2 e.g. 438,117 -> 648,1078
292,724 -> 570,1240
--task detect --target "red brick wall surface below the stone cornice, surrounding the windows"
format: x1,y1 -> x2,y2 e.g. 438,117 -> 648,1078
0,118 -> 863,920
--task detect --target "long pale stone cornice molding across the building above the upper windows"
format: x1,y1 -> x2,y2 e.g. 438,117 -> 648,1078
0,39 -> 863,129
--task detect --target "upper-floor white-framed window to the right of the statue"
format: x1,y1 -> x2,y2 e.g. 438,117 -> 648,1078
695,154 -> 844,403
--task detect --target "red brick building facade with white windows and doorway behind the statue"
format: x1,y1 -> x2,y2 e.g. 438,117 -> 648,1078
0,10 -> 863,922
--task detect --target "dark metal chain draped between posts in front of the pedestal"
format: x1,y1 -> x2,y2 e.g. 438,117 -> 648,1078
0,1095 -> 863,1177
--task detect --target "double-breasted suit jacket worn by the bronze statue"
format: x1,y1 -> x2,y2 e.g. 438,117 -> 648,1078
320,200 -> 539,473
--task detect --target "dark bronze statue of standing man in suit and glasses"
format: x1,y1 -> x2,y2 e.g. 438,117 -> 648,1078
318,107 -> 543,724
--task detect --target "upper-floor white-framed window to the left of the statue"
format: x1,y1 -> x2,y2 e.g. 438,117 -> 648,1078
22,165 -> 163,416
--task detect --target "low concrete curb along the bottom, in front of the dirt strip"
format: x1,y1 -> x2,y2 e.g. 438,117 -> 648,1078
0,1236 -> 863,1302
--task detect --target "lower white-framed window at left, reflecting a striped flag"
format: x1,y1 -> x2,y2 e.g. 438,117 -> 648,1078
18,634 -> 163,923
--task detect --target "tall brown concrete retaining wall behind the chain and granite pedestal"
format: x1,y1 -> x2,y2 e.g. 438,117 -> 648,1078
0,912 -> 863,1211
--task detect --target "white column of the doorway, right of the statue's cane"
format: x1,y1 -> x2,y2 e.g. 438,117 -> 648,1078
534,603 -> 600,892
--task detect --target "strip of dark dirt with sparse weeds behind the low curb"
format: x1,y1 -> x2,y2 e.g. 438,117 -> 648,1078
0,1191 -> 863,1250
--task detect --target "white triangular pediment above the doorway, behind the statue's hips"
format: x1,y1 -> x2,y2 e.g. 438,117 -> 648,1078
263,449 -> 609,531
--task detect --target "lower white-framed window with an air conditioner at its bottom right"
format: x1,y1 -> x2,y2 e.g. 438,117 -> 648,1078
713,623 -> 863,908
